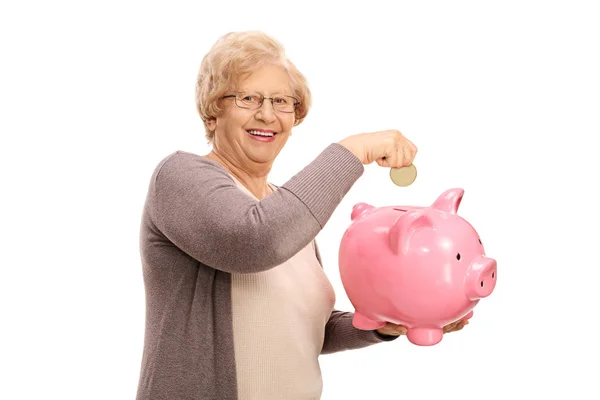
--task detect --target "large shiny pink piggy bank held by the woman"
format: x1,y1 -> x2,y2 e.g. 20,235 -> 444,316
339,189 -> 498,346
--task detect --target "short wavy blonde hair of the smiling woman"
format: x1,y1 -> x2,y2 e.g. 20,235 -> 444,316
196,31 -> 312,143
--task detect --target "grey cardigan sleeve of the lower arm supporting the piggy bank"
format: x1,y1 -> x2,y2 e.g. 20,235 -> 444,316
315,240 -> 398,354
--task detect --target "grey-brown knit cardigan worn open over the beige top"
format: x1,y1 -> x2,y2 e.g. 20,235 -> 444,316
137,144 -> 396,400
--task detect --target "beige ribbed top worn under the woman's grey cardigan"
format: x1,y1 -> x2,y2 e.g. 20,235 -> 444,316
231,178 -> 335,400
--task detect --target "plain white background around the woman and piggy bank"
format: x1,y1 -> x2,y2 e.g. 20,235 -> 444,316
0,1 -> 600,400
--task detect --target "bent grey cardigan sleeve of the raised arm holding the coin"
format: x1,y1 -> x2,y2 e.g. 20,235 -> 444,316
147,144 -> 364,273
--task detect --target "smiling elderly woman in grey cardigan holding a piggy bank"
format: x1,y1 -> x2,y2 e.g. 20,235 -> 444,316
137,32 -> 463,400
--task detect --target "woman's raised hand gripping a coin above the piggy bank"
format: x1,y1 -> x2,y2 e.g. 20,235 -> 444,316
339,130 -> 417,168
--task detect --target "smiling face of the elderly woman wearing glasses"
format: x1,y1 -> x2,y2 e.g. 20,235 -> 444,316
208,65 -> 295,168
